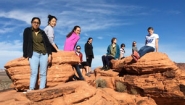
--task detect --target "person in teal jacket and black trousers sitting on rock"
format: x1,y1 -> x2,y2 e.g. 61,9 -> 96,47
102,38 -> 120,70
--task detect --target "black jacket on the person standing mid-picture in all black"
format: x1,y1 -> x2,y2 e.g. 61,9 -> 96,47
85,42 -> 94,58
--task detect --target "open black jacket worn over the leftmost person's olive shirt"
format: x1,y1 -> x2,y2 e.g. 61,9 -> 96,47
23,27 -> 51,58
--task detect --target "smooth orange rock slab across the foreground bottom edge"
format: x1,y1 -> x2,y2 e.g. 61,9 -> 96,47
0,81 -> 156,105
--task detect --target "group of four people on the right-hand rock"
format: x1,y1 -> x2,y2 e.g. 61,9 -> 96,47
101,27 -> 159,70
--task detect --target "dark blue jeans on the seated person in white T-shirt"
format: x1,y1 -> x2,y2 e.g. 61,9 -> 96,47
138,46 -> 155,57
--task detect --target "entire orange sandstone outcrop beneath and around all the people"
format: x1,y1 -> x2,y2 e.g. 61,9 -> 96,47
0,52 -> 185,105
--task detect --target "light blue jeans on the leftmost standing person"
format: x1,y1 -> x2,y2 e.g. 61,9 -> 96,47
29,52 -> 48,90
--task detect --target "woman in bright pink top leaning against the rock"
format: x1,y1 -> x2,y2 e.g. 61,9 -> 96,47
64,26 -> 84,80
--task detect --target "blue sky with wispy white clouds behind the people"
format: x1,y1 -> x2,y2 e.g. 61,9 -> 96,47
0,0 -> 185,68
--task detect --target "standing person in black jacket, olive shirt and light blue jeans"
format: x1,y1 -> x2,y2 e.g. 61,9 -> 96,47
22,17 -> 51,91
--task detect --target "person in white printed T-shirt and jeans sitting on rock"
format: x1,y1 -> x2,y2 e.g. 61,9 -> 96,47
132,27 -> 159,61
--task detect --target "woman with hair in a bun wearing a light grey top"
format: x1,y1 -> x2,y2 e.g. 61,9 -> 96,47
44,15 -> 60,52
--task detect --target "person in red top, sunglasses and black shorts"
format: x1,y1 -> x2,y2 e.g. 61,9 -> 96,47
75,45 -> 90,76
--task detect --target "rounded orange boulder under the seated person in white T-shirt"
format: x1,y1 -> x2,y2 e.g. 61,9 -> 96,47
112,52 -> 178,74
